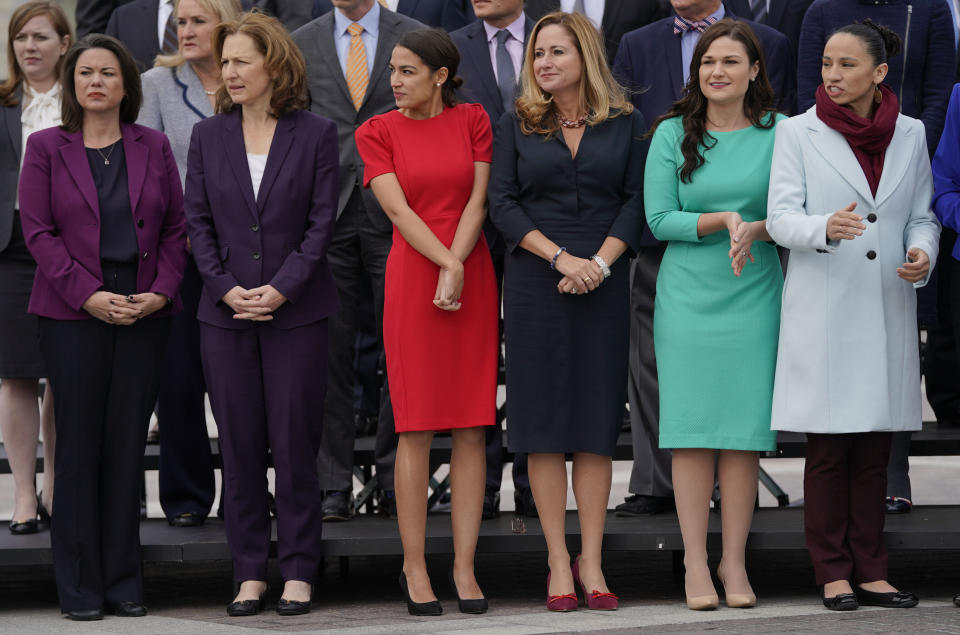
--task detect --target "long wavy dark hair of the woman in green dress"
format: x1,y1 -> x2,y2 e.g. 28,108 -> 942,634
649,18 -> 777,183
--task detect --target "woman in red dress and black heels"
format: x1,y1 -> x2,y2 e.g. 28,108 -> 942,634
356,29 -> 499,615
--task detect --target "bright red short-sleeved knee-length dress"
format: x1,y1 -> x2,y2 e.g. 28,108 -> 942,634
356,104 -> 499,432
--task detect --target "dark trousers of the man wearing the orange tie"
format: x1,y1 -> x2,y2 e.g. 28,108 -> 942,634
317,189 -> 397,490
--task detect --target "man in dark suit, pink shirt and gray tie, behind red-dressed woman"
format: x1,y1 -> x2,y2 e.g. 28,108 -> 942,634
450,0 -> 536,518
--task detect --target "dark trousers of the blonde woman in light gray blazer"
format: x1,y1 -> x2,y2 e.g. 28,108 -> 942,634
157,258 -> 216,520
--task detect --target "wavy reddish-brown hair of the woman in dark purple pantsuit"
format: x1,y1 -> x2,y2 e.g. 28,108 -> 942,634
213,10 -> 310,118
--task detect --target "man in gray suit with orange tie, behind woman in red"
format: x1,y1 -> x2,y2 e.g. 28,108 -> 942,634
293,0 -> 423,520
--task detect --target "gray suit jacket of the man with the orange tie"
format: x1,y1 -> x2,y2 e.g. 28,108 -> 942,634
293,9 -> 423,232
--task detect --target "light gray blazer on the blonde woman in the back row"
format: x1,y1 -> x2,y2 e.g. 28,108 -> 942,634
137,63 -> 213,185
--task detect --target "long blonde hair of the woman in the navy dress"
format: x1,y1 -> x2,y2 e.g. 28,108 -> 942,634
516,11 -> 633,135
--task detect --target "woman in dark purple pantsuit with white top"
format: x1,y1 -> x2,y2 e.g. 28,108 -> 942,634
186,13 -> 339,616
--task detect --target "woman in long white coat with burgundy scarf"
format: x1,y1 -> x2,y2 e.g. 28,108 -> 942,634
767,20 -> 940,610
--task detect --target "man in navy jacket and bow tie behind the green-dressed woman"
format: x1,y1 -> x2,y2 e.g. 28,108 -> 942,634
613,0 -> 796,516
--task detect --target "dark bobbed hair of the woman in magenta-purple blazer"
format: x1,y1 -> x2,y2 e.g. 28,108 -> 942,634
60,33 -> 143,132
